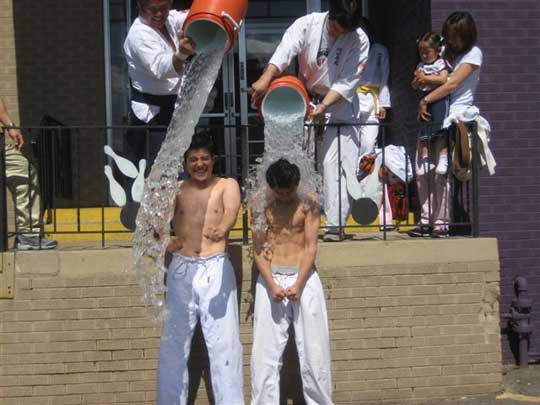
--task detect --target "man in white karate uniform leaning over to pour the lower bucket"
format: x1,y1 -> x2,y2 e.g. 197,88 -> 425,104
252,0 -> 369,241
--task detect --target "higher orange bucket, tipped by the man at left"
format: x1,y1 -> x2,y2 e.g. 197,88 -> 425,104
184,0 -> 248,52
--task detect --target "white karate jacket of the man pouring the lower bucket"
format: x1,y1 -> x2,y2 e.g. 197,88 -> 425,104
269,12 -> 369,121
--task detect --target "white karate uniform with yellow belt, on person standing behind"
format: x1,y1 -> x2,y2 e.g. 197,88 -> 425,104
357,43 -> 391,156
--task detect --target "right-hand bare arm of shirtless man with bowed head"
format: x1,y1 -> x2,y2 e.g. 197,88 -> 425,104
287,196 -> 321,301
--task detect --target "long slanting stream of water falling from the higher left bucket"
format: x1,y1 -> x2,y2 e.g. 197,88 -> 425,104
133,47 -> 224,318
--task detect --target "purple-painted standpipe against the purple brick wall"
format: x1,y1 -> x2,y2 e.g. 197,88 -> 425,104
501,276 -> 540,367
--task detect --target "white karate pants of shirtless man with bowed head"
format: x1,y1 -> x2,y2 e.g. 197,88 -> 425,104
251,271 -> 332,405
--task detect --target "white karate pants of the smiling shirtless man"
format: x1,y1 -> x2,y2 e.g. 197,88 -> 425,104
157,253 -> 244,405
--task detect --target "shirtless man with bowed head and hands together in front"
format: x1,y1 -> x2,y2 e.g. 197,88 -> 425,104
251,159 -> 332,405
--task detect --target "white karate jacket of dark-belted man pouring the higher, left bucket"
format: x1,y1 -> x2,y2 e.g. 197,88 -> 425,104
124,10 -> 187,122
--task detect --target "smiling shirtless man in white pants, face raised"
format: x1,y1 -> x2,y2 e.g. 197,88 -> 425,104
157,133 -> 244,405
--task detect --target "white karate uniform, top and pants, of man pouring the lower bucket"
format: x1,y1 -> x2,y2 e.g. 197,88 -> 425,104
269,12 -> 369,227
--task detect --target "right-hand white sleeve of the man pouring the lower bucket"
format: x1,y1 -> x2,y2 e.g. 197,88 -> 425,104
330,28 -> 369,103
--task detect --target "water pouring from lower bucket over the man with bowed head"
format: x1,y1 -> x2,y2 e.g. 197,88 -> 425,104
246,111 -> 322,233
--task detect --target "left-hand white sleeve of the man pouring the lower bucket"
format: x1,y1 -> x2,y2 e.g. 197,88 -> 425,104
268,15 -> 310,73
